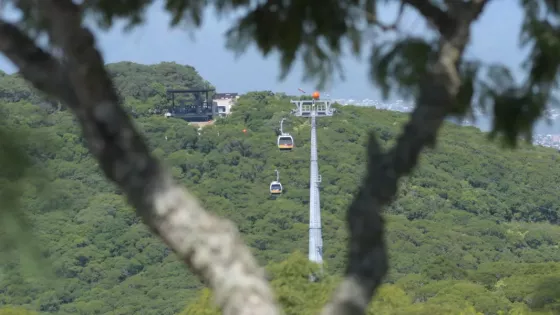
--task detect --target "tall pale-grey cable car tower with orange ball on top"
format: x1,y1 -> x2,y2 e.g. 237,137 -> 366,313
290,89 -> 335,278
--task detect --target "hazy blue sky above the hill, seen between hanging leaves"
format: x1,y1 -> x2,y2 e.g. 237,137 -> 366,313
0,0 -> 523,99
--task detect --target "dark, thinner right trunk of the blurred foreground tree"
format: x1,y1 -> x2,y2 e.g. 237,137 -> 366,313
322,0 -> 486,315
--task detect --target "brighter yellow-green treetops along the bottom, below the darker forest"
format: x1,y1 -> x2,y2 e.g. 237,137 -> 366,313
186,252 -> 560,315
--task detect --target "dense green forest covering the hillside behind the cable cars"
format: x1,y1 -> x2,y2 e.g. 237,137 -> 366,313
0,62 -> 560,315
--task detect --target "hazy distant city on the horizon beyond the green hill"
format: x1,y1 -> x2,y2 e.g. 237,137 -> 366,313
333,99 -> 560,150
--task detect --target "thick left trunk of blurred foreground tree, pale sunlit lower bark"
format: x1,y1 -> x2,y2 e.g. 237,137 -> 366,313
6,0 -> 279,315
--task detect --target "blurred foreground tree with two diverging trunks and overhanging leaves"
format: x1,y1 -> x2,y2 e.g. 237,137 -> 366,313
0,0 -> 560,314
